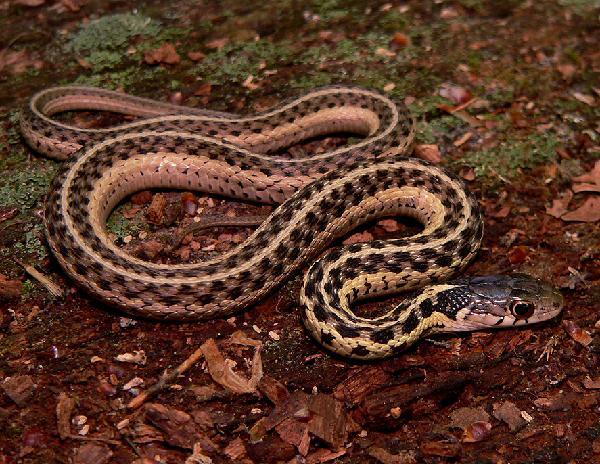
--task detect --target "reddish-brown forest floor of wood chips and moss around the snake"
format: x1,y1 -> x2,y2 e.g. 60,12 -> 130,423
0,0 -> 600,464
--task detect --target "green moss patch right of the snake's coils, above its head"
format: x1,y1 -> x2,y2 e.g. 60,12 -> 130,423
457,133 -> 559,179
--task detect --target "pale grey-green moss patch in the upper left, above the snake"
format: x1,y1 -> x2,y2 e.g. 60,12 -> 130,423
68,13 -> 161,55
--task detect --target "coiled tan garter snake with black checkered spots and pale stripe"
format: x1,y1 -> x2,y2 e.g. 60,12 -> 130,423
20,85 -> 563,360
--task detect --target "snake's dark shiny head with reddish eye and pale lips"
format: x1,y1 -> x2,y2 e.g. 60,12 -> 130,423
437,274 -> 564,332
